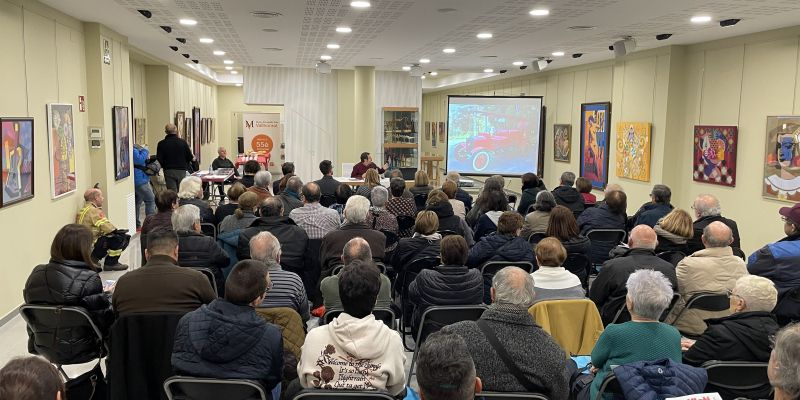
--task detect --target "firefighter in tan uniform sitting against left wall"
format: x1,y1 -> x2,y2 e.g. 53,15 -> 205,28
75,188 -> 131,271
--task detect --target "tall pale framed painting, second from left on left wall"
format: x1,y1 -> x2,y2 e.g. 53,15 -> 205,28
47,103 -> 77,199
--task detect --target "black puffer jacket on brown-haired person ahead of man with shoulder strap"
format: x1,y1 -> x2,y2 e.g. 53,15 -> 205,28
408,265 -> 483,332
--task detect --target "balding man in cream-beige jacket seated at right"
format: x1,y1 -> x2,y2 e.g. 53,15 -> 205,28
667,221 -> 747,335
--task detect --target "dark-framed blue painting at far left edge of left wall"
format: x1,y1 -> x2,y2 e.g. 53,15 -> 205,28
0,118 -> 34,207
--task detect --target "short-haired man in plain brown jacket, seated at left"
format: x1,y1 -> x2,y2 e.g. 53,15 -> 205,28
111,230 -> 217,316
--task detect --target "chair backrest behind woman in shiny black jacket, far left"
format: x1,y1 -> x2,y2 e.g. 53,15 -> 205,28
19,304 -> 108,365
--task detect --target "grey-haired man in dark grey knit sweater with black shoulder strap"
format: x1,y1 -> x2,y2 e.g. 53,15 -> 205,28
442,266 -> 570,400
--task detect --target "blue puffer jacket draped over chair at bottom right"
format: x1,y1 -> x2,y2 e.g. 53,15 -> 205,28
614,358 -> 708,400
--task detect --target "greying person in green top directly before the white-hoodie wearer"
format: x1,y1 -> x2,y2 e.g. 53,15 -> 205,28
319,237 -> 392,310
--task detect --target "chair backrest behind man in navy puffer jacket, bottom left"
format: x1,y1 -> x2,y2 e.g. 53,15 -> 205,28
164,376 -> 267,400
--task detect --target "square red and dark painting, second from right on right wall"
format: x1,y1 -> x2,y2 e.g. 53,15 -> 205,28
692,125 -> 739,186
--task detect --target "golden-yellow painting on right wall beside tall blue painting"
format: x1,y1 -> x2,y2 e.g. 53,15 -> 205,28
617,122 -> 650,182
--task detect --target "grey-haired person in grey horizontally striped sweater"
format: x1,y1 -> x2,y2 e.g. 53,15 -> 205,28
250,232 -> 311,322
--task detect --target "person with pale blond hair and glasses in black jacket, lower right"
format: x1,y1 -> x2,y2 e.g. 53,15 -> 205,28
681,275 -> 779,367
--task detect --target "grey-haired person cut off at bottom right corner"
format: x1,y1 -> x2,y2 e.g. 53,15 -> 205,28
767,324 -> 800,400
